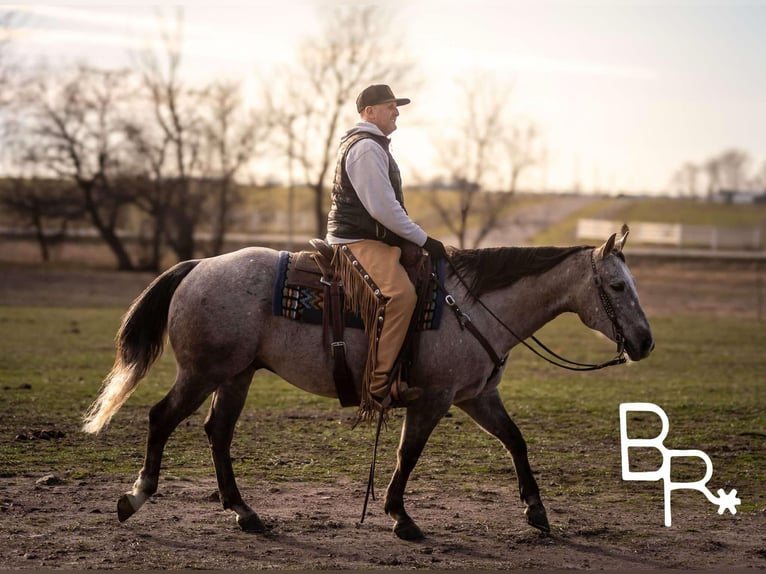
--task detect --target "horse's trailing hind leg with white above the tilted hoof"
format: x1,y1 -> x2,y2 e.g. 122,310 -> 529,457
117,371 -> 215,522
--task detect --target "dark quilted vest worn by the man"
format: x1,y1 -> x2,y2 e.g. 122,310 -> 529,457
327,132 -> 404,245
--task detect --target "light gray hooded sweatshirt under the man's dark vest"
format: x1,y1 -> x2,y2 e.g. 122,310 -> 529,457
326,122 -> 428,246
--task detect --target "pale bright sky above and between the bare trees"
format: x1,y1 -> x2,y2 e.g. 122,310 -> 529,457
0,0 -> 766,193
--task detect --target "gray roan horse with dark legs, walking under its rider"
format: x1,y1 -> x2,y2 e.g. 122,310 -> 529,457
83,227 -> 654,540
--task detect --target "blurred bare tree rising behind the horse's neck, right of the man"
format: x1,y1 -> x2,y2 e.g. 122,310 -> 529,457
430,75 -> 542,248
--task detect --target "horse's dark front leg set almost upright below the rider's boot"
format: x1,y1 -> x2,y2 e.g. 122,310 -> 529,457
385,397 -> 450,540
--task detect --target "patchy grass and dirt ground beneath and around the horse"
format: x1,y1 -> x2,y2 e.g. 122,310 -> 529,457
0,255 -> 766,571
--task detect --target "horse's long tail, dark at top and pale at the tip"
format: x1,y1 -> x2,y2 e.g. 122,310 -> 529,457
82,260 -> 199,434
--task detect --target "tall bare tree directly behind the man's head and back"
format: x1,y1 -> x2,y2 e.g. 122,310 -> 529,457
272,4 -> 413,236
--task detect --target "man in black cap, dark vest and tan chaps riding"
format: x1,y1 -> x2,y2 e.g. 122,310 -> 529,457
326,84 -> 445,412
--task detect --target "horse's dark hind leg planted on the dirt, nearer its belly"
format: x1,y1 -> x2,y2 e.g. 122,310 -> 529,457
205,369 -> 266,532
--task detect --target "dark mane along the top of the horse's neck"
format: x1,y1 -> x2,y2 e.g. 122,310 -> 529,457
450,245 -> 590,296
